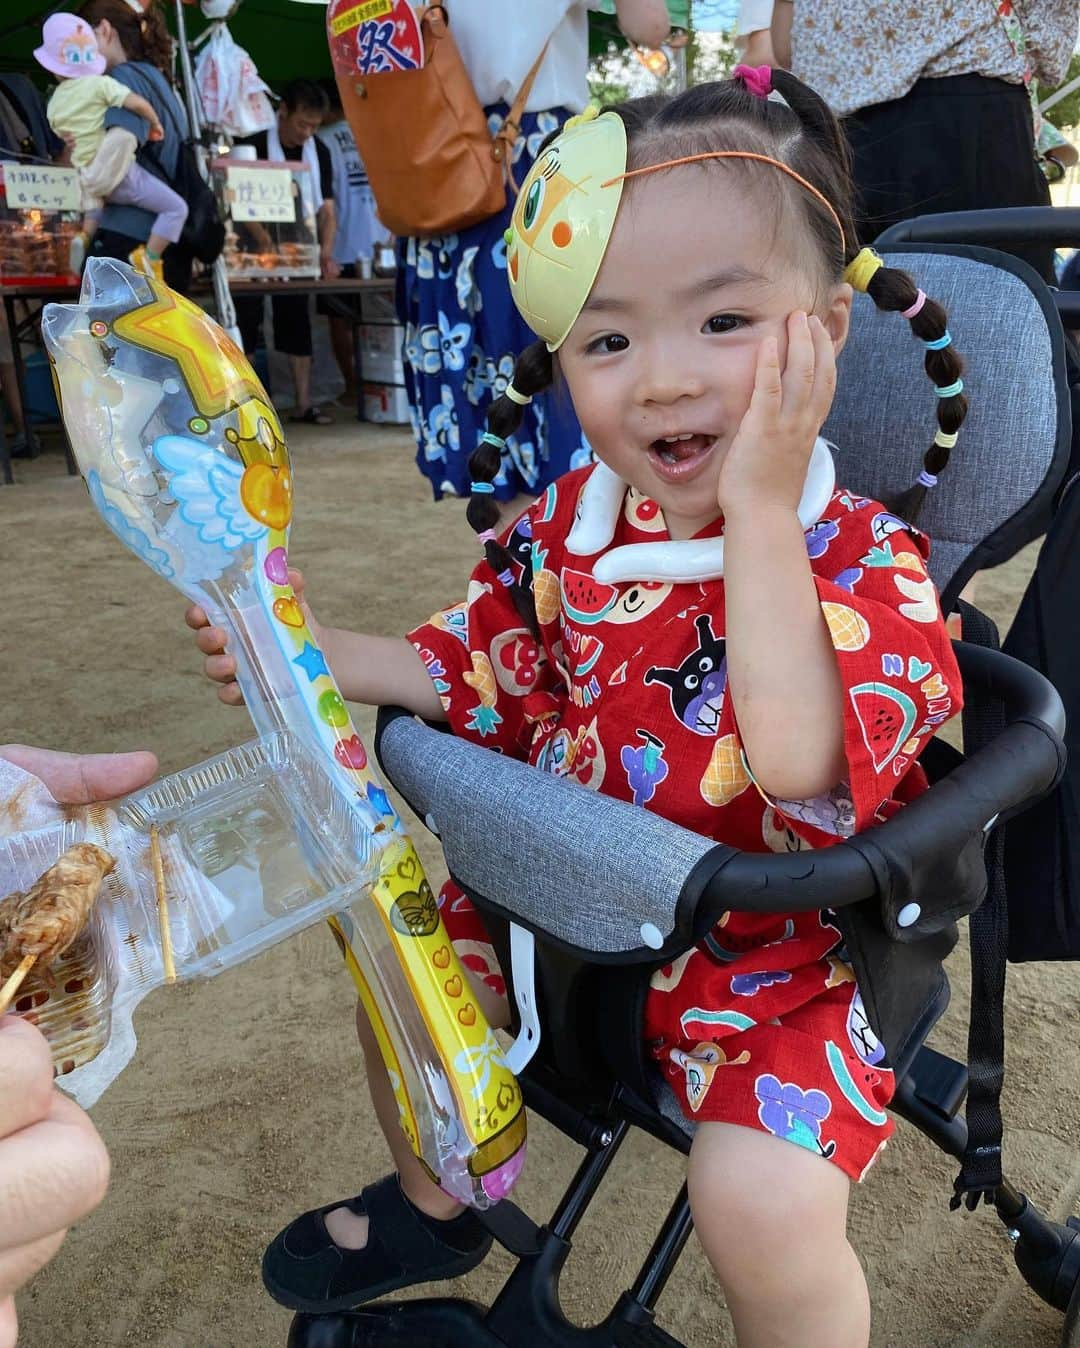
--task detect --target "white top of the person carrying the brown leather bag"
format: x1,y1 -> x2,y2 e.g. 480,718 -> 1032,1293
446,0 -> 600,112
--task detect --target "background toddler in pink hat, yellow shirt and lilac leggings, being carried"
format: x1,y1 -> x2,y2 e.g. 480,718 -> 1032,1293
34,13 -> 187,280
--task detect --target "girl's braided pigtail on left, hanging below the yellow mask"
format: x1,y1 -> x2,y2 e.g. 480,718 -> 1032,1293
465,341 -> 553,635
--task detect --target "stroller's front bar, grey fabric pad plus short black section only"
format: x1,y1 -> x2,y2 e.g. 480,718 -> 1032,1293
376,708 -> 895,964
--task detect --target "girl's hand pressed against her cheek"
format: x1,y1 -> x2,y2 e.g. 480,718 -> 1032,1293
716,310 -> 836,516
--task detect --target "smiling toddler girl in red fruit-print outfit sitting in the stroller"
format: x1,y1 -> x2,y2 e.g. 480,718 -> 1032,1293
189,67 -> 967,1348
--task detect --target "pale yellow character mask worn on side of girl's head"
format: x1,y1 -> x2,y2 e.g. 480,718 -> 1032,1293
506,112 -> 626,350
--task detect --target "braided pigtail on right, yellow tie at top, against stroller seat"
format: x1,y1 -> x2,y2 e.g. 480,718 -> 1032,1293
844,248 -> 968,523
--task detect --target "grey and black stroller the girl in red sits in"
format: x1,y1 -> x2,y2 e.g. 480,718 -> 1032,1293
289,223 -> 1080,1348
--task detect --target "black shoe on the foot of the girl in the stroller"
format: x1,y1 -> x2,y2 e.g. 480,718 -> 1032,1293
263,1174 -> 491,1314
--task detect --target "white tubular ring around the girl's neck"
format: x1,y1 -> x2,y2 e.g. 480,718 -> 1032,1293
566,435 -> 836,585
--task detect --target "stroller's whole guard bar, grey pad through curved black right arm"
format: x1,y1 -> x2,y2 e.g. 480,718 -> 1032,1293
376,643 -> 1064,962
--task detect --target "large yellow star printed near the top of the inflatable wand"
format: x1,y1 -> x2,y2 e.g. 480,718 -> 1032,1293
112,278 -> 268,421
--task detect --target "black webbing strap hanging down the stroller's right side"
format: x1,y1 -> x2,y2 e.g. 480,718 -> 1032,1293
949,600 -> 1009,1211
